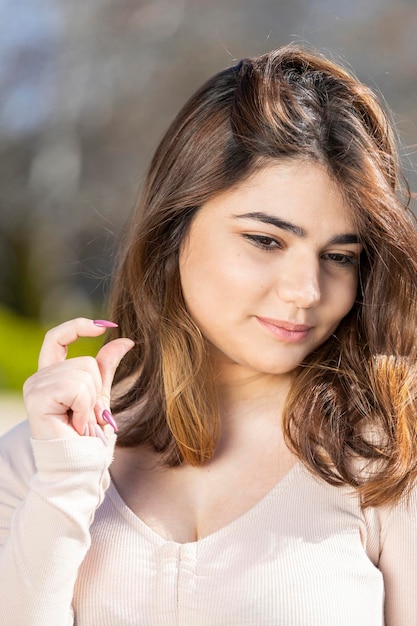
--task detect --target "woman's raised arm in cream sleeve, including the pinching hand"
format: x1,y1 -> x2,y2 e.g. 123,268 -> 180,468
0,318 -> 133,626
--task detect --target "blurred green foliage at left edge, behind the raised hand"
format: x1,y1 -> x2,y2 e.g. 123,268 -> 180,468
0,305 -> 103,390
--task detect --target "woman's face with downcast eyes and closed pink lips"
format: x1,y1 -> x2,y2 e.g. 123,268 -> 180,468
180,162 -> 362,374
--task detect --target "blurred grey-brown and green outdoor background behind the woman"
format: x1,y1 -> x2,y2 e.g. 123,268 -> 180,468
0,0 -> 417,432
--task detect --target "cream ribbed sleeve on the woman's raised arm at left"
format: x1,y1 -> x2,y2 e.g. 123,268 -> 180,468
0,420 -> 115,626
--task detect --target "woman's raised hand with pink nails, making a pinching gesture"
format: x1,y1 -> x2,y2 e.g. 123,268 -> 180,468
23,318 -> 134,439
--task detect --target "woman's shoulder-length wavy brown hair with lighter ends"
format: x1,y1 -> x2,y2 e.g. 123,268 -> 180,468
111,45 -> 417,506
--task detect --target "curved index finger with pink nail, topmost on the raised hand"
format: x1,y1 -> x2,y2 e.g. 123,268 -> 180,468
38,317 -> 117,369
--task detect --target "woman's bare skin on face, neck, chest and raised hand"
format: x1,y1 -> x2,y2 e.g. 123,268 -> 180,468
26,162 -> 361,542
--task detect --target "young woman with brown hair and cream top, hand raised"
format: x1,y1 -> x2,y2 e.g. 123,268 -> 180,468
0,46 -> 417,626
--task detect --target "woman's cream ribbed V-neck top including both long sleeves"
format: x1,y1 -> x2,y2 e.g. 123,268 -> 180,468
0,426 -> 417,626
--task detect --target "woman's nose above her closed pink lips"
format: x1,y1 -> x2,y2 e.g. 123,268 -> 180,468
278,259 -> 321,309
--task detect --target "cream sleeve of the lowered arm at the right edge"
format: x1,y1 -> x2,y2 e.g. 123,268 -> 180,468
379,488 -> 417,626
